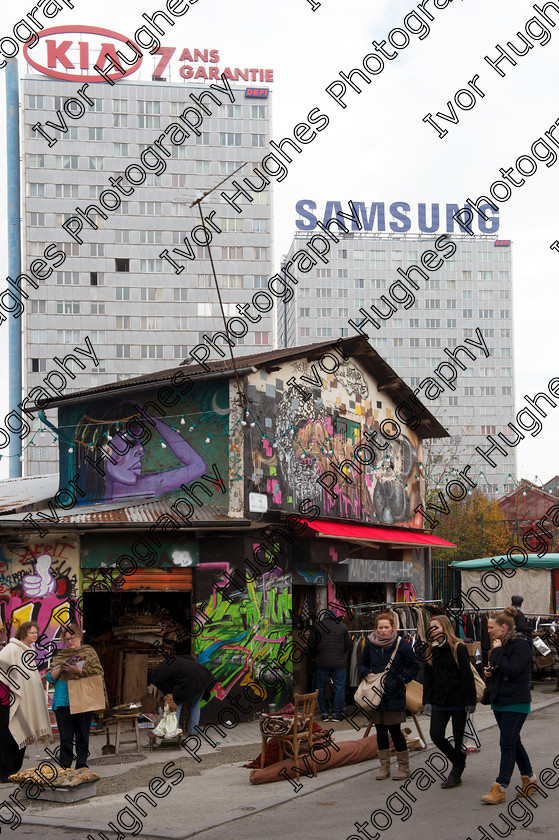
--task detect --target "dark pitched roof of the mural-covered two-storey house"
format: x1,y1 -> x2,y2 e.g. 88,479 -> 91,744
26,336 -> 449,438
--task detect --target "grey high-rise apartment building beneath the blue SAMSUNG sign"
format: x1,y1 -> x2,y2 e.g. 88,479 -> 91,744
278,230 -> 516,493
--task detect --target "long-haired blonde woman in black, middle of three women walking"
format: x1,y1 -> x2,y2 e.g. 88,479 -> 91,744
423,615 -> 476,788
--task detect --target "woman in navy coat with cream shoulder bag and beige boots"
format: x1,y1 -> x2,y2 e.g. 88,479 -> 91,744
359,613 -> 419,779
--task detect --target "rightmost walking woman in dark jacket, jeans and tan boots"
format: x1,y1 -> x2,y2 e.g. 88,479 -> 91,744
481,607 -> 538,805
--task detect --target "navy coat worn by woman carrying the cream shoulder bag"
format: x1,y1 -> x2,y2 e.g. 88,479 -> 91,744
359,639 -> 419,712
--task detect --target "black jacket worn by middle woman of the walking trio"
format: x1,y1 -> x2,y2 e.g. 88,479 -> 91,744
423,642 -> 476,706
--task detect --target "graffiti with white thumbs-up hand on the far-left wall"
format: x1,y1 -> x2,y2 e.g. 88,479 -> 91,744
0,540 -> 79,669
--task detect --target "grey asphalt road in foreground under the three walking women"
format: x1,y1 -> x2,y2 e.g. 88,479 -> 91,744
5,704 -> 559,840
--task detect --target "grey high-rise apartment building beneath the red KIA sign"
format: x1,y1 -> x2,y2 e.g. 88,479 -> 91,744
21,74 -> 274,475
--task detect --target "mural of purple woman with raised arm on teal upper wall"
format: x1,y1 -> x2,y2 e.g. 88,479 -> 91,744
60,382 -> 229,504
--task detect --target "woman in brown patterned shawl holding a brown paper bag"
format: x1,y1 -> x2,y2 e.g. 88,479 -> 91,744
47,623 -> 108,770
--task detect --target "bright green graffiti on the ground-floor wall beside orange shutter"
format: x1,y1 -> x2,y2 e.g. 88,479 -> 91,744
195,563 -> 292,703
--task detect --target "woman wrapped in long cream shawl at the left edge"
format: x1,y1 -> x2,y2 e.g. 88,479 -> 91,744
0,621 -> 52,784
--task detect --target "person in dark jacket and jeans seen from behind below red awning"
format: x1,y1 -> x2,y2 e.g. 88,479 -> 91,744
309,610 -> 351,720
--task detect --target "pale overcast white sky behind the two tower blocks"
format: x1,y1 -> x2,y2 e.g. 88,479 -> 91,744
0,0 -> 559,481
